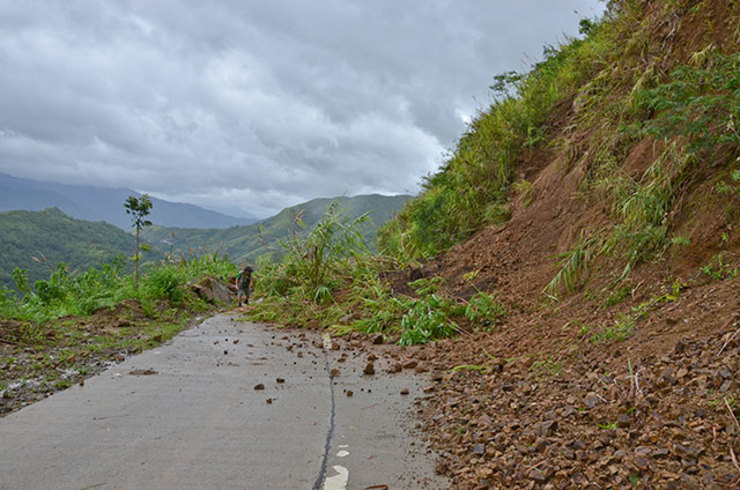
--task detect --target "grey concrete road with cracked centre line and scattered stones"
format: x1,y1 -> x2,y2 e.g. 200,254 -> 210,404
0,315 -> 447,490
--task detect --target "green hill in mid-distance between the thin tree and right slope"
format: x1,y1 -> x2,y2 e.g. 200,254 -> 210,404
143,194 -> 409,262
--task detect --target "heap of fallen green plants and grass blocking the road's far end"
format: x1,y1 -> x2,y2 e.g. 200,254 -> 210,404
248,206 -> 506,345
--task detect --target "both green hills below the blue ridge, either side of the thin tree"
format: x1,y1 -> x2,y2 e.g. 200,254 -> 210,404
0,192 -> 409,288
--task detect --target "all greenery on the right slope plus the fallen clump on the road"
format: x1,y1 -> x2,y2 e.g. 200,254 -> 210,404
251,1 -> 740,344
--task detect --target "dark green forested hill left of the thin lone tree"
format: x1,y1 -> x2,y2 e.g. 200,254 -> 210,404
0,208 -> 134,287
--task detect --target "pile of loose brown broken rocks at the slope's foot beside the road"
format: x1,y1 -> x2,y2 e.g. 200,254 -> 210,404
420,332 -> 740,489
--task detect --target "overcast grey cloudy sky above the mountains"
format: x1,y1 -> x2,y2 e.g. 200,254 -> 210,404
0,0 -> 605,217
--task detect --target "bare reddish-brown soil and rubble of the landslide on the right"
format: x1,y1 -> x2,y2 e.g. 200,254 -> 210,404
384,0 -> 740,489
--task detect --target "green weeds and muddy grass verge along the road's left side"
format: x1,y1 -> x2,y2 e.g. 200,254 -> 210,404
0,203 -> 237,414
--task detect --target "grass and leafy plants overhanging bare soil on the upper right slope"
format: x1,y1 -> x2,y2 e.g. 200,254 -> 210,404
546,48 -> 740,297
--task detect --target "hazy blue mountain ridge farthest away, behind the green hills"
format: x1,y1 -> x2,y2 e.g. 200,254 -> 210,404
0,173 -> 257,230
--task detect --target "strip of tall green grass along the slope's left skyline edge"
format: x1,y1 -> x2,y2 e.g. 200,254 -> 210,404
379,17 -> 605,259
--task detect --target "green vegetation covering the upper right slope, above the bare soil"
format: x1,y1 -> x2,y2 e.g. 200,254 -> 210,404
380,1 -> 740,276
